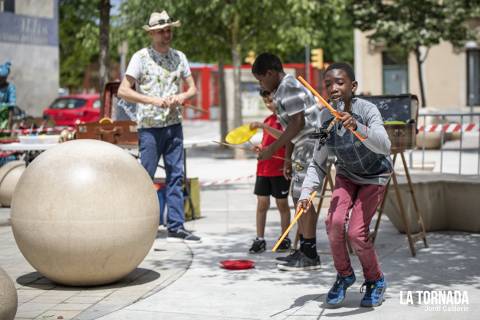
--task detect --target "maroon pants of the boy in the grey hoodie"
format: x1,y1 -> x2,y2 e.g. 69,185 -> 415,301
325,175 -> 385,281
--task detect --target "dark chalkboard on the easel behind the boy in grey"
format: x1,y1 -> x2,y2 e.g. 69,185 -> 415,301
357,94 -> 418,122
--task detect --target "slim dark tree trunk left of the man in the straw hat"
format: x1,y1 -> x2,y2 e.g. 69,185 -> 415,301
98,0 -> 111,104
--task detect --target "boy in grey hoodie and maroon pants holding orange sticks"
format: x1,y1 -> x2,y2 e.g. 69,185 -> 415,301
297,63 -> 393,307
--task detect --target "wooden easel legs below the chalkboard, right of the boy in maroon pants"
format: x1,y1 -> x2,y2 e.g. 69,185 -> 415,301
369,150 -> 428,257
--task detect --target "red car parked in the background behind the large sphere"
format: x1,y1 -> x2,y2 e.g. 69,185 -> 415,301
43,94 -> 101,126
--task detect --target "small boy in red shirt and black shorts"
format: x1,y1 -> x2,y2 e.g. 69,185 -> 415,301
249,90 -> 291,253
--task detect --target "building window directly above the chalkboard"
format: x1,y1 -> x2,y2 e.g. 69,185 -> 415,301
382,49 -> 408,94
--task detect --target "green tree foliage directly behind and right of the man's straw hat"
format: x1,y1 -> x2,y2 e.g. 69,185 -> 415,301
120,0 -> 353,63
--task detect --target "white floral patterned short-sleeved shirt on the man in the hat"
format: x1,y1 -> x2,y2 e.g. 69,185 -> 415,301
126,47 -> 191,128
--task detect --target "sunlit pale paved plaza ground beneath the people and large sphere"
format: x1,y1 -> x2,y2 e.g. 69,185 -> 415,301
0,123 -> 480,320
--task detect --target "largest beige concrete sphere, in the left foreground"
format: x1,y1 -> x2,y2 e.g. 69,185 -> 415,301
12,140 -> 159,286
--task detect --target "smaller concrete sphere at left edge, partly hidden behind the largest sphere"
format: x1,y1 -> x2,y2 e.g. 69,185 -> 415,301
0,161 -> 25,207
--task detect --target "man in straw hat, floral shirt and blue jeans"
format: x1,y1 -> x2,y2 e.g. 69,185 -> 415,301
118,11 -> 200,242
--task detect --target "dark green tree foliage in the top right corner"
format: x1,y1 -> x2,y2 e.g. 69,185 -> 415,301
351,0 -> 478,51
